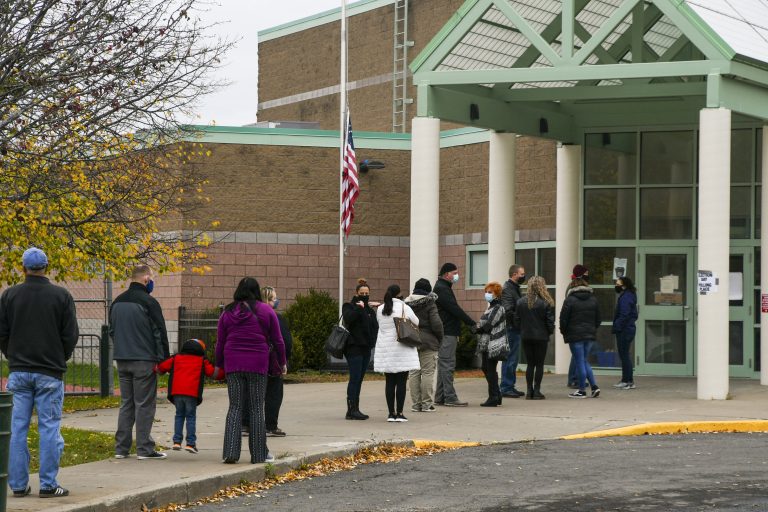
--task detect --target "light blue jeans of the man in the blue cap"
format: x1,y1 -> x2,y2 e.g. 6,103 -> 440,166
3,372 -> 64,492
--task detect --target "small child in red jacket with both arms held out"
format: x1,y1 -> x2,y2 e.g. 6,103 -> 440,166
155,339 -> 224,453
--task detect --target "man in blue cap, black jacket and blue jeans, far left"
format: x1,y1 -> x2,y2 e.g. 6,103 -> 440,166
0,247 -> 78,498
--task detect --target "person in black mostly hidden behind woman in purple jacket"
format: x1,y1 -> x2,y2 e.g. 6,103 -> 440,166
260,286 -> 293,437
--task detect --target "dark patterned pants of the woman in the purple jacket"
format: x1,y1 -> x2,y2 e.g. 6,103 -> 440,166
224,372 -> 267,463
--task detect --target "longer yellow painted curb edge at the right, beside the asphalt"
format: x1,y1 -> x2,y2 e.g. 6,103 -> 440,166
560,420 -> 768,439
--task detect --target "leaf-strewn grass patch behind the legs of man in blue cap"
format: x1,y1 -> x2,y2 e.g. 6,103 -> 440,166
27,422 -> 115,473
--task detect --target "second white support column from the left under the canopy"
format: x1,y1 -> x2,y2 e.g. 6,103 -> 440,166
488,132 -> 516,283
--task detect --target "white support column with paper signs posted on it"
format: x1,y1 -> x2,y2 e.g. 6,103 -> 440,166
696,108 -> 731,400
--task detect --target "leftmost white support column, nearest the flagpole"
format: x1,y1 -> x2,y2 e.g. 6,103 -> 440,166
412,117 -> 440,290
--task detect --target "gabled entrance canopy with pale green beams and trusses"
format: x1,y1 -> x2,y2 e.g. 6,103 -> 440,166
411,0 -> 768,143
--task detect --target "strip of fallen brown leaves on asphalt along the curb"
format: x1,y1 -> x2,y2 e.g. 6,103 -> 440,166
153,443 -> 459,512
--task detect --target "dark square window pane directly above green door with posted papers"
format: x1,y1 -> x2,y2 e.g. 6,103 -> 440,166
640,188 -> 693,240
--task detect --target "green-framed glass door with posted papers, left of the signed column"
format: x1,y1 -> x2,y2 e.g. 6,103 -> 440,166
635,247 -> 695,375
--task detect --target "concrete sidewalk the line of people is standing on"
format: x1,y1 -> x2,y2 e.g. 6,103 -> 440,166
8,376 -> 768,512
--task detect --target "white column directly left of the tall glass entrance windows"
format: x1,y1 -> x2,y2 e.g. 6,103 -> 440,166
555,142 -> 581,374
